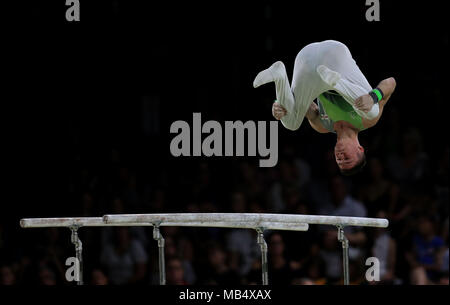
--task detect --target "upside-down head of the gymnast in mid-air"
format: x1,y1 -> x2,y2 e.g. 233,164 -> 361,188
334,137 -> 366,176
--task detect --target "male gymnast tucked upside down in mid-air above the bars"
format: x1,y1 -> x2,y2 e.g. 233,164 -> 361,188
253,40 -> 396,175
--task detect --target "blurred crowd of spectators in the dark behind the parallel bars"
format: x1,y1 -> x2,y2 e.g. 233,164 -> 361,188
0,110 -> 449,285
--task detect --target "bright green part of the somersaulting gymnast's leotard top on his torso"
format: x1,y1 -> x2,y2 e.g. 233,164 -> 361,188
318,92 -> 364,130
